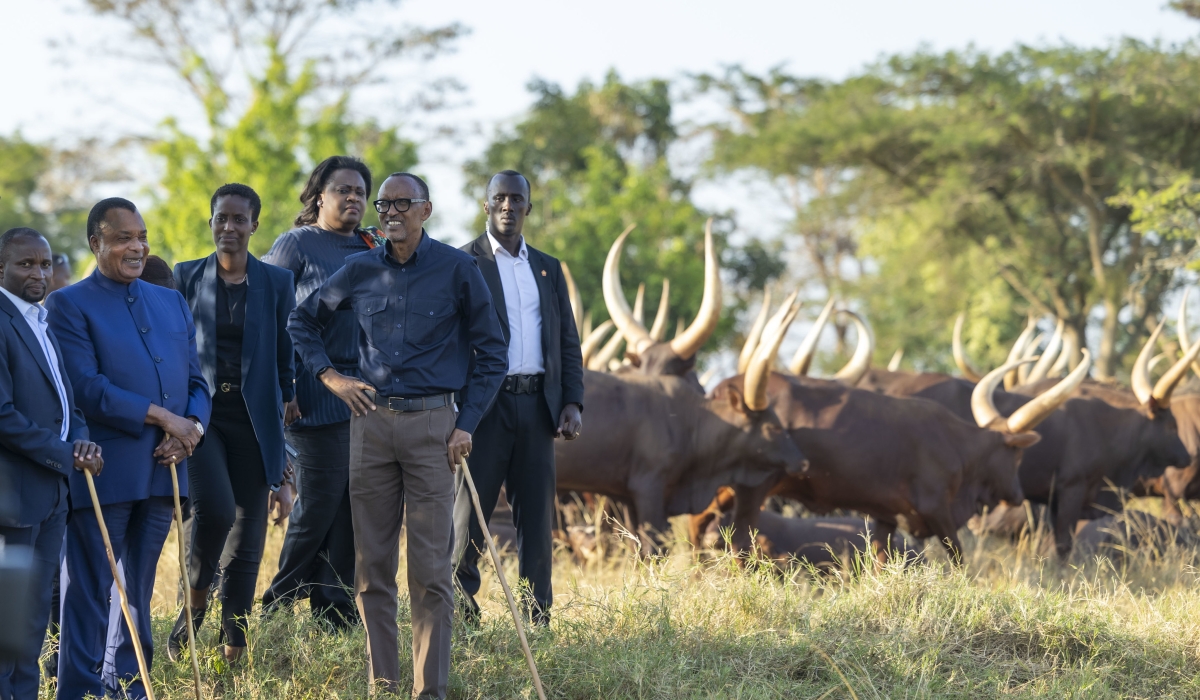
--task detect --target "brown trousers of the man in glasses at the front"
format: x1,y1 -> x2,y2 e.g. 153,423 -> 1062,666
350,407 -> 455,698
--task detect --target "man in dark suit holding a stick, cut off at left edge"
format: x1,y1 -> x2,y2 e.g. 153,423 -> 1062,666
0,228 -> 104,700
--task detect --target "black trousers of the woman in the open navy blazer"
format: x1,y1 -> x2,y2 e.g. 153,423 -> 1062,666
187,391 -> 270,646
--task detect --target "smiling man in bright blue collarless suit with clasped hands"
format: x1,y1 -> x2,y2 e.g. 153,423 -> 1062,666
46,197 -> 211,700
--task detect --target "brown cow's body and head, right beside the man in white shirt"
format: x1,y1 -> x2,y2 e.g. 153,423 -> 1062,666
554,355 -> 805,546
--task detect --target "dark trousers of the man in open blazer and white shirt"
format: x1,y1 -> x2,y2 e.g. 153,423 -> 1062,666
455,391 -> 554,622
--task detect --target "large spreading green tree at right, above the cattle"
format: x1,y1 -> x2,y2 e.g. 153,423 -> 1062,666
713,40 -> 1200,377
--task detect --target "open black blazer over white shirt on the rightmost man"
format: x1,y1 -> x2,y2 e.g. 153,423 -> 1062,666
462,233 -> 583,427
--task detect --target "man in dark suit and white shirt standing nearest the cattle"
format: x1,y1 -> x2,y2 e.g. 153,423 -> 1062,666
455,170 -> 583,624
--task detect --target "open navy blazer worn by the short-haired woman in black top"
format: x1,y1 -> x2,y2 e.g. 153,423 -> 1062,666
175,253 -> 296,484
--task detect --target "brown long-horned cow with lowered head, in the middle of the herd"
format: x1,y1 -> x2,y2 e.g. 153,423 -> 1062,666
700,353 -> 1086,562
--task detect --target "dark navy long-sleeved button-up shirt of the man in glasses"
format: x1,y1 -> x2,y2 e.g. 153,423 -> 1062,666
288,232 -> 508,432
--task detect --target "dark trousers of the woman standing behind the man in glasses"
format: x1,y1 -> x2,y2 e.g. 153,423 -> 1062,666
263,420 -> 358,627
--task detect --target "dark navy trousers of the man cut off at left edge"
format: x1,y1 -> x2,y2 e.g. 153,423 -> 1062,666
0,499 -> 67,700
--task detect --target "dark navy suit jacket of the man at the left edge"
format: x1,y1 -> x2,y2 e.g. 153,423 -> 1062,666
0,294 -> 88,527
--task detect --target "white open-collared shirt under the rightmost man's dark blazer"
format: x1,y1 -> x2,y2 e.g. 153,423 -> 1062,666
487,232 -> 546,375
